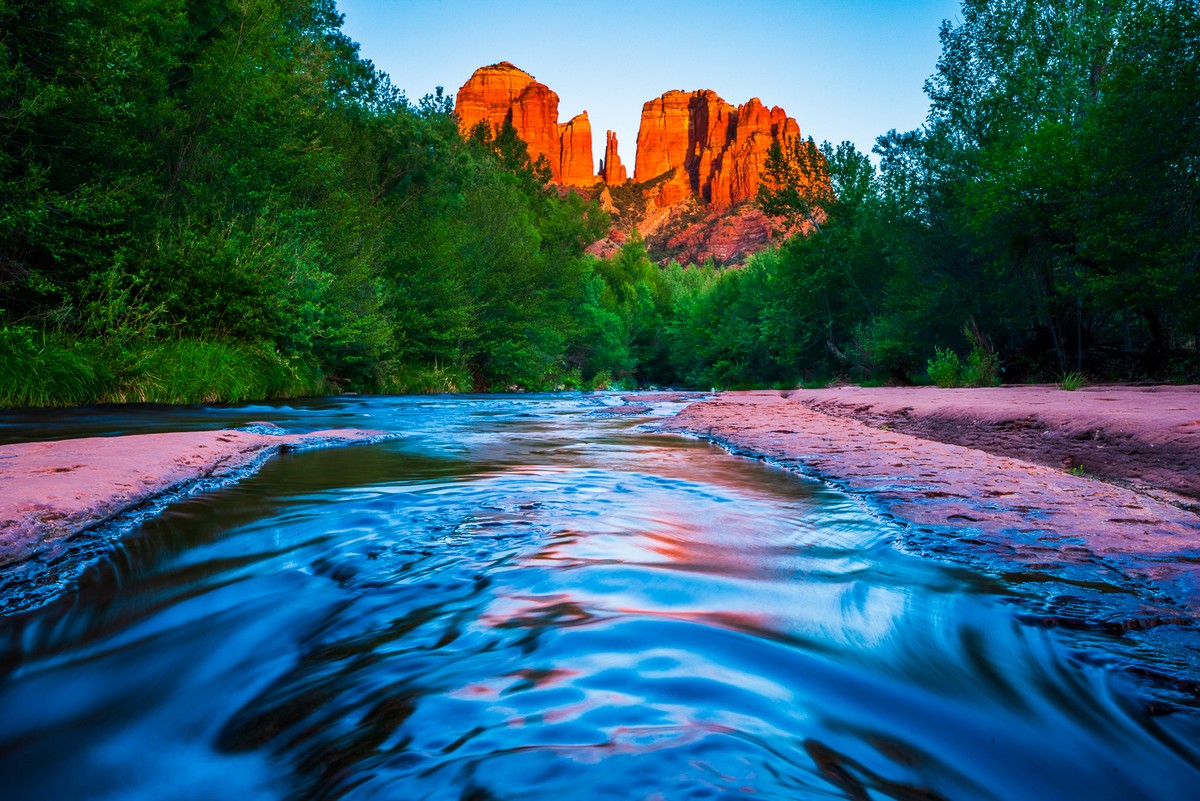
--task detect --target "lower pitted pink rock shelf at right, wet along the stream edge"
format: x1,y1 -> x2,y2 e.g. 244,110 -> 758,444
661,392 -> 1200,628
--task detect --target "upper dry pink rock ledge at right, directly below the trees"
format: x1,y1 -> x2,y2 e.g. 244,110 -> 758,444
788,386 -> 1200,504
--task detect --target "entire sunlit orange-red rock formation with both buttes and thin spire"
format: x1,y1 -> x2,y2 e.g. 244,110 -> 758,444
456,61 -> 800,263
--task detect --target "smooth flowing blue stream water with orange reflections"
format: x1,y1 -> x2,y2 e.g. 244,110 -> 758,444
0,396 -> 1200,801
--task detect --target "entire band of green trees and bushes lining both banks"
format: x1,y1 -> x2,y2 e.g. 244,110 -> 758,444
0,0 -> 1200,405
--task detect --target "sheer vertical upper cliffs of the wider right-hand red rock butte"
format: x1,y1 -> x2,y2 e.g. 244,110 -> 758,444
634,90 -> 800,207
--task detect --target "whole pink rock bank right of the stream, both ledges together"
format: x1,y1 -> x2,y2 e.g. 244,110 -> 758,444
662,386 -> 1200,618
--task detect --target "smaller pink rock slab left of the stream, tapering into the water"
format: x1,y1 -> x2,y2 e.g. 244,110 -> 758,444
0,429 -> 384,565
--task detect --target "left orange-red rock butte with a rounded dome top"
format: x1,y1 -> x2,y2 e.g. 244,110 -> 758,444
455,61 -> 596,186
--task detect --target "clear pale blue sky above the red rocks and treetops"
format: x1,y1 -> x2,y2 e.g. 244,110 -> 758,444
337,0 -> 959,174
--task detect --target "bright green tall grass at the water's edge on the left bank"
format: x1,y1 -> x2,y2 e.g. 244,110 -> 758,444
0,327 -> 331,406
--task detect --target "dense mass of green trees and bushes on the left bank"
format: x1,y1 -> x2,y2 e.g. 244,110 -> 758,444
0,0 -> 608,404
